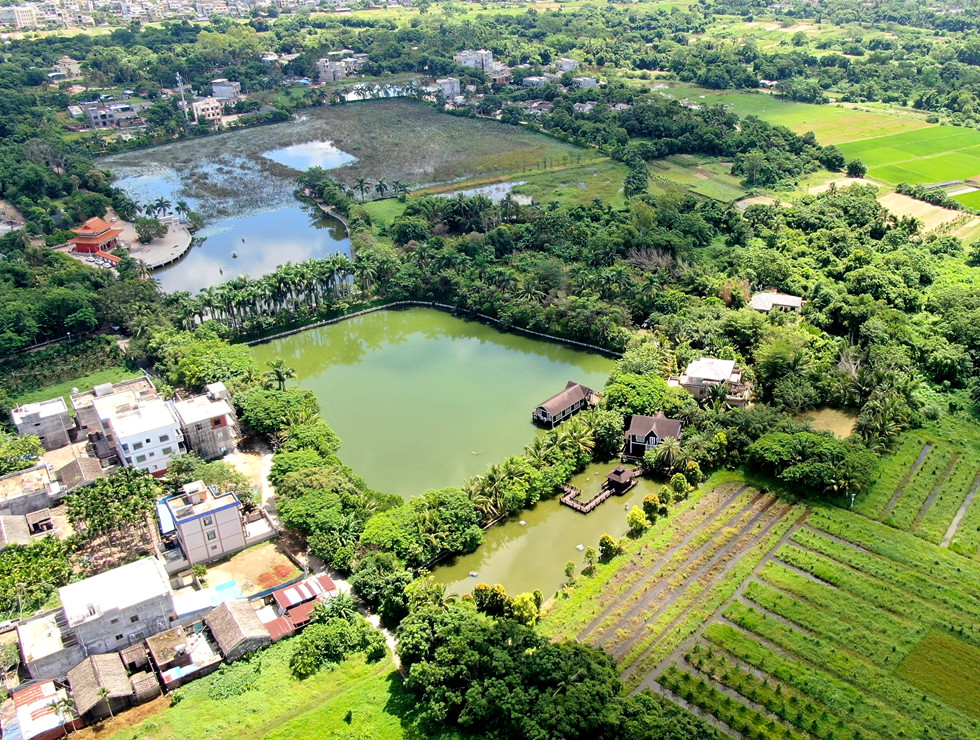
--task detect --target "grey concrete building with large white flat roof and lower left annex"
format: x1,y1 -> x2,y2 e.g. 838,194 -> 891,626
17,557 -> 176,679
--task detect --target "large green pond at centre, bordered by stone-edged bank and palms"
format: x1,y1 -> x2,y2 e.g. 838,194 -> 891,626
252,309 -> 613,500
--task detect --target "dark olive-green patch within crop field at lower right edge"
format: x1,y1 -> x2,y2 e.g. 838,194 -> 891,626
896,629 -> 980,717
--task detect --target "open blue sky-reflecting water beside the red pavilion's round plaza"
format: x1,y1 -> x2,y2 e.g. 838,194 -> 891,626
153,203 -> 349,293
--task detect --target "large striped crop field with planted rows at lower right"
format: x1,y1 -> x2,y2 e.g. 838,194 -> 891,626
543,416 -> 980,740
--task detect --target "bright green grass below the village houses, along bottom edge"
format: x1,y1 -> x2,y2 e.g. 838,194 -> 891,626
86,639 -> 454,740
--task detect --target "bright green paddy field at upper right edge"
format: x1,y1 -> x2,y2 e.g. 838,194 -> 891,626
840,126 -> 980,183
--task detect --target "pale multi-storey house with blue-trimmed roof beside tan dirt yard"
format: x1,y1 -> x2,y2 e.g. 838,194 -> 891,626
160,481 -> 246,565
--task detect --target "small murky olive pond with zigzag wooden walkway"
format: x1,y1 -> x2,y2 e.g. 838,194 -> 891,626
433,461 -> 662,599
